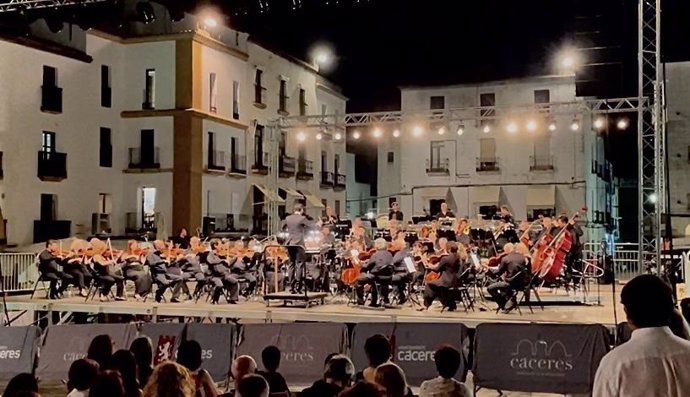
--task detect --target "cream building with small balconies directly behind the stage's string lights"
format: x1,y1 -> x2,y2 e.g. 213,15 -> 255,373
378,76 -> 610,238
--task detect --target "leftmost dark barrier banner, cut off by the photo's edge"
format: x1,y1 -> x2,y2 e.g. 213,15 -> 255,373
0,326 -> 41,379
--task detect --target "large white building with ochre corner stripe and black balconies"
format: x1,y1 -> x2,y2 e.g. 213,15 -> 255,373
0,6 -> 346,244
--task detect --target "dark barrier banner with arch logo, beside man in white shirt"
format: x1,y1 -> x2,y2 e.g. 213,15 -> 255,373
474,324 -> 608,394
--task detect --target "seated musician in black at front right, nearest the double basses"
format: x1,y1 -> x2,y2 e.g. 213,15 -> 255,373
487,243 -> 530,312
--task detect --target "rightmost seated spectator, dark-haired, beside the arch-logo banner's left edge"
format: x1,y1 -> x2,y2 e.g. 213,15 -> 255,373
419,346 -> 472,397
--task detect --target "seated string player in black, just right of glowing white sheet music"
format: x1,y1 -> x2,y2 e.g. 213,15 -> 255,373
418,239 -> 460,311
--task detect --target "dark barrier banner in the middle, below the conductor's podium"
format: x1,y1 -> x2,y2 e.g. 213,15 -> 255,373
237,323 -> 347,385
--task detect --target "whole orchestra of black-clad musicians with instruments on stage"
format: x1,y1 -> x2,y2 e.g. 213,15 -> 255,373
37,202 -> 583,311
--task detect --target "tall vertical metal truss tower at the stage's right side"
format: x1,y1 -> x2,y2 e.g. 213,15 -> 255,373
637,0 -> 666,271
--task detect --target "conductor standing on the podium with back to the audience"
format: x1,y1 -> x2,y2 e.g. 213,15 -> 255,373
283,203 -> 313,294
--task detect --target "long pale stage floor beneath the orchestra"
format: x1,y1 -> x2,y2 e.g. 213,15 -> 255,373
1,287 -> 625,328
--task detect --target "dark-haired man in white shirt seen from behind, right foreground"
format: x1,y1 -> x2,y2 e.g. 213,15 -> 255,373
592,274 -> 690,397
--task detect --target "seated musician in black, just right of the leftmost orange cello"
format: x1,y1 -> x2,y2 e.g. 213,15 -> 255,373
356,238 -> 393,307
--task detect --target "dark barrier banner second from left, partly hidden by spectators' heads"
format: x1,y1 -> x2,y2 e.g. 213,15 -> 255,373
37,324 -> 136,380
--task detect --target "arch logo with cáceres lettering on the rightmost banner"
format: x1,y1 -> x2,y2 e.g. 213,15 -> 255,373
510,339 -> 575,377
